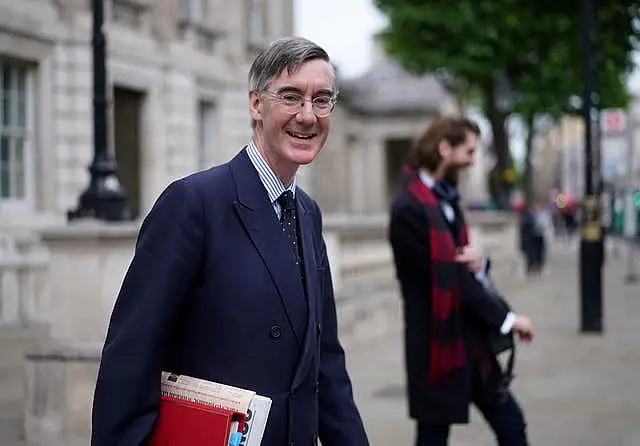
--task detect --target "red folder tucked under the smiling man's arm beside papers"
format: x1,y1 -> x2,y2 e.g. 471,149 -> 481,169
148,395 -> 246,446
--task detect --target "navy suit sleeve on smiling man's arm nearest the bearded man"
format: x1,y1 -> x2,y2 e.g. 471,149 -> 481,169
316,207 -> 369,446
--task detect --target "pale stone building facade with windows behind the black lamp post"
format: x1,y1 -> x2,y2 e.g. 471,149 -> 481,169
0,0 -> 293,225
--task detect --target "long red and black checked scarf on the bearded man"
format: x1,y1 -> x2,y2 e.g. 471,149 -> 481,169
405,167 -> 469,386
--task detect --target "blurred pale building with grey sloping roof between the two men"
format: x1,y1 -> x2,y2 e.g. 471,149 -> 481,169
307,56 -> 456,215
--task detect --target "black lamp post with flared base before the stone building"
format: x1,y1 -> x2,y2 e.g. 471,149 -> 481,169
67,0 -> 133,221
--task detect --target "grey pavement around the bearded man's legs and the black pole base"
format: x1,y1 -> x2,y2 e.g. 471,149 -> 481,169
345,240 -> 640,446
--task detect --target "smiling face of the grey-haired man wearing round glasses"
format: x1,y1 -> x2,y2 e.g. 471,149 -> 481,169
249,59 -> 334,179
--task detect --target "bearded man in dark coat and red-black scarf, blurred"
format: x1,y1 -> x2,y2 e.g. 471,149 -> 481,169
389,117 -> 533,446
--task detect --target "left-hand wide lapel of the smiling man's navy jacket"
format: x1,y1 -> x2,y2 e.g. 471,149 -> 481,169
230,150 -> 307,346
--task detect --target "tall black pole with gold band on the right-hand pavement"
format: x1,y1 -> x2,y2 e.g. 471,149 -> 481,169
580,0 -> 604,333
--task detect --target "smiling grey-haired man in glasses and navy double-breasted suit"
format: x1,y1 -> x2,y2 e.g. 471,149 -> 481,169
91,37 -> 369,446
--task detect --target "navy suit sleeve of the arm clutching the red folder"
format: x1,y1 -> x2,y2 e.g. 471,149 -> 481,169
91,180 -> 204,446
